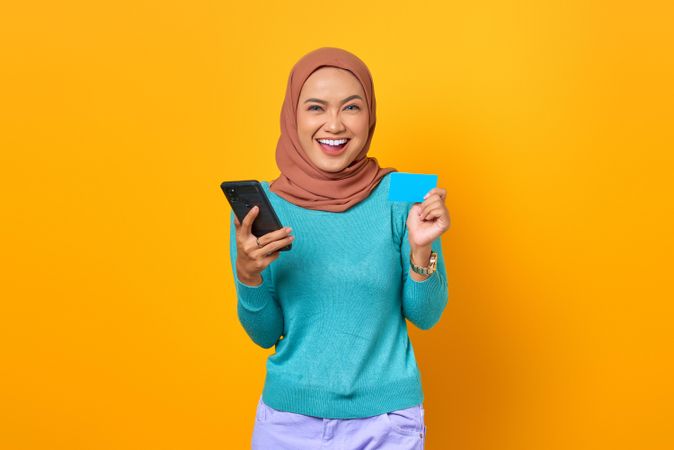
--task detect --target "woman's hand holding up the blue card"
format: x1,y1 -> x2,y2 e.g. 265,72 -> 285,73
407,187 -> 449,250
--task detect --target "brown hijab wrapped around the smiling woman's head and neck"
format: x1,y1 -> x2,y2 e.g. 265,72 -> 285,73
269,47 -> 397,212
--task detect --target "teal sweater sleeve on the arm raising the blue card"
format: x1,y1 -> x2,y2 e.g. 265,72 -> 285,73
393,202 -> 448,330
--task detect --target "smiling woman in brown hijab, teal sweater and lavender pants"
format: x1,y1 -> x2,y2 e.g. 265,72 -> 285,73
230,47 -> 449,450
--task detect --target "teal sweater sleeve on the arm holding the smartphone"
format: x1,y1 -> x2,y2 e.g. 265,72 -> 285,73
229,211 -> 283,348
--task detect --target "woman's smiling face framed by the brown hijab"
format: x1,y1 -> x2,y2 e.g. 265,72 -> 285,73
297,67 -> 370,172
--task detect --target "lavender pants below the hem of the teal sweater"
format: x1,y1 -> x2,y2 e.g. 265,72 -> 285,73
252,396 -> 426,450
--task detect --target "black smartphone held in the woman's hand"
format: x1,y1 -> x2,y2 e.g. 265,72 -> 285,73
220,180 -> 292,251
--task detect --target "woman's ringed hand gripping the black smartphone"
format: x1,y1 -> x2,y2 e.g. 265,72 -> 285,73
234,206 -> 295,285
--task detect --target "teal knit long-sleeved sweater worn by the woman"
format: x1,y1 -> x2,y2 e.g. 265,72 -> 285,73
230,174 -> 448,419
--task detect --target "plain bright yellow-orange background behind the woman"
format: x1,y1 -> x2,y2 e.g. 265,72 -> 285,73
0,0 -> 674,450
